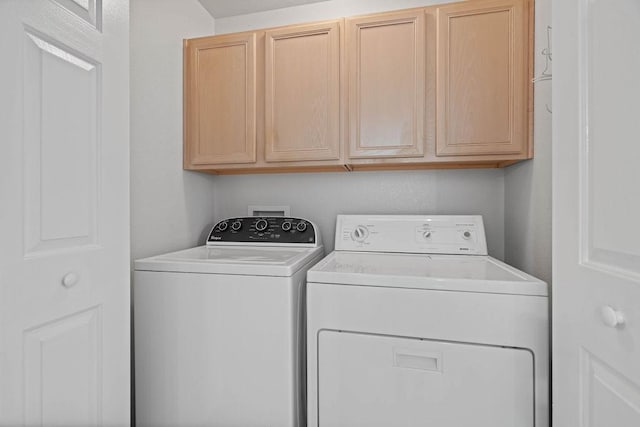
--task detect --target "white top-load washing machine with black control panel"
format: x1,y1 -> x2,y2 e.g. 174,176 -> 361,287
133,217 -> 324,427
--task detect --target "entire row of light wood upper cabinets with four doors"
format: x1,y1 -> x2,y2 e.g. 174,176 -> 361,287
184,0 -> 533,173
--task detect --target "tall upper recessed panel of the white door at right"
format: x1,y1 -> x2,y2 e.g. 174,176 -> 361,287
580,0 -> 640,280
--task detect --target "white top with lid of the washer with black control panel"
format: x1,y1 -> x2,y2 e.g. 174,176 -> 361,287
135,246 -> 323,277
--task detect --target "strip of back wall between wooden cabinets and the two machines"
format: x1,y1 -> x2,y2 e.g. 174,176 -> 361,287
215,169 -> 504,259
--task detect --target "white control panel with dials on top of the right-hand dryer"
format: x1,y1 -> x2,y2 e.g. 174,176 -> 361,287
336,215 -> 487,255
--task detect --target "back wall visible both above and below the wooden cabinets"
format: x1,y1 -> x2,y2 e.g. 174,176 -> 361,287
215,0 -> 505,259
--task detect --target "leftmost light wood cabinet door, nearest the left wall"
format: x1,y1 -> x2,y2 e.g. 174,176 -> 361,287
184,33 -> 256,168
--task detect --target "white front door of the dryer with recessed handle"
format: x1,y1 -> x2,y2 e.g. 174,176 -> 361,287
318,330 -> 534,427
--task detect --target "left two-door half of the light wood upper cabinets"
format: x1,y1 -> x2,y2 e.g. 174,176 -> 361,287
184,19 -> 345,173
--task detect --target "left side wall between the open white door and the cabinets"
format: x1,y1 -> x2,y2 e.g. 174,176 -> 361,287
131,0 -> 219,259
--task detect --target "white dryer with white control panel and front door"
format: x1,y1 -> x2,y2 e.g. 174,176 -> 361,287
307,215 -> 549,427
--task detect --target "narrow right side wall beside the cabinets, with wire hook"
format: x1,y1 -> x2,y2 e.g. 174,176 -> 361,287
505,0 -> 551,283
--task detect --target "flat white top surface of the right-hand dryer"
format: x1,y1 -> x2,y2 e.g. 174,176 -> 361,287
307,251 -> 547,296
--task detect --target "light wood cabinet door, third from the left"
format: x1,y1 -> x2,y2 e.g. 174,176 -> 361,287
346,9 -> 425,159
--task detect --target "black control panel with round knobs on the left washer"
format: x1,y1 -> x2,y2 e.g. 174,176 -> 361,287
207,216 -> 317,245
